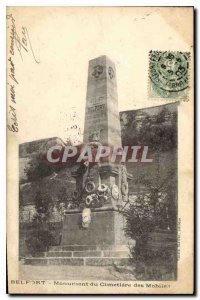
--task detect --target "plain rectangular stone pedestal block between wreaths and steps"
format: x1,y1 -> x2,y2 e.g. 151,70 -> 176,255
61,211 -> 126,246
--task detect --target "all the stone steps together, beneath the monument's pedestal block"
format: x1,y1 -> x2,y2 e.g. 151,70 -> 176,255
23,245 -> 129,266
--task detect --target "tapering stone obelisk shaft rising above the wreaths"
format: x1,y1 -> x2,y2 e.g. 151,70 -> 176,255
83,55 -> 121,147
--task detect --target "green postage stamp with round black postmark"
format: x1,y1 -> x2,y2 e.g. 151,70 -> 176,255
149,51 -> 190,101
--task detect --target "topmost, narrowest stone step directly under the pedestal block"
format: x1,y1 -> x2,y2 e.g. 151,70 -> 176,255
49,245 -> 128,251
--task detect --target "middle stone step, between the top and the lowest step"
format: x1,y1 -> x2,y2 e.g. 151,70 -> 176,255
44,250 -> 129,258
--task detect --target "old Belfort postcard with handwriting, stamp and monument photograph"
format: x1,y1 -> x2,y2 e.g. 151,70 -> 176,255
6,7 -> 194,294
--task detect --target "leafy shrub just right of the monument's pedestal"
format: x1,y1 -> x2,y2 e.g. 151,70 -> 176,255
123,162 -> 176,239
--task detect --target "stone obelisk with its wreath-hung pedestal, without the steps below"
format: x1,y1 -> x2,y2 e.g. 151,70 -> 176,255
61,56 -> 128,262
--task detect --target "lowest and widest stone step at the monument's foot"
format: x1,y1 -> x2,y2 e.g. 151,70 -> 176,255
24,257 -> 129,266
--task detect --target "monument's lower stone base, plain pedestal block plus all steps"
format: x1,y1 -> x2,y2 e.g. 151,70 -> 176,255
24,210 -> 129,266
